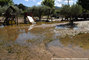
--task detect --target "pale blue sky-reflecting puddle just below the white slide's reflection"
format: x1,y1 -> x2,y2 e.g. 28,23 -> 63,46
16,31 -> 45,45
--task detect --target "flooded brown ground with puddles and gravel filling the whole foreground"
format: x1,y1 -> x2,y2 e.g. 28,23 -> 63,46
0,21 -> 89,60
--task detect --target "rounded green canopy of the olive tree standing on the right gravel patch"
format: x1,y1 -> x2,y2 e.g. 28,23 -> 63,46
60,4 -> 82,17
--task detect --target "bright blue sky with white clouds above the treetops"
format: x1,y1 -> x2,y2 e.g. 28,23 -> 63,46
13,0 -> 77,7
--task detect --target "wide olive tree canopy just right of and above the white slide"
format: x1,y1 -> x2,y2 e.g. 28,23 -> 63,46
28,6 -> 54,20
